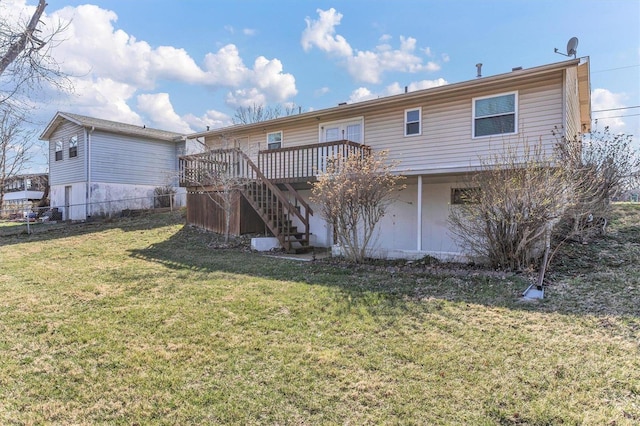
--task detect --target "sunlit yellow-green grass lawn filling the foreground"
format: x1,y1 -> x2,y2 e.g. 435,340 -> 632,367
0,205 -> 640,425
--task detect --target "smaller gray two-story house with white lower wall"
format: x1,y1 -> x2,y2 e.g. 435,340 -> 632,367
40,112 -> 185,220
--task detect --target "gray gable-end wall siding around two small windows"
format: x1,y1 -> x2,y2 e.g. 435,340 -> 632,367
49,122 -> 86,186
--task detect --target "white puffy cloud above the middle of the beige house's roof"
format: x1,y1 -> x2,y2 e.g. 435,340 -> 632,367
301,8 -> 440,83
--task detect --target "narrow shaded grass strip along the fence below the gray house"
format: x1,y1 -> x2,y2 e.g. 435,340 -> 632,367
0,210 -> 184,247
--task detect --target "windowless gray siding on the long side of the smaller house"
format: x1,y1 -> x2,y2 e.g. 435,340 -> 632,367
90,131 -> 177,186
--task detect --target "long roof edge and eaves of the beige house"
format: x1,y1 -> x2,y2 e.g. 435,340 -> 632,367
186,57 -> 591,139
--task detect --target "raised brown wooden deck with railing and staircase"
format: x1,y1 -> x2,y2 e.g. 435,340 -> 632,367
180,140 -> 370,252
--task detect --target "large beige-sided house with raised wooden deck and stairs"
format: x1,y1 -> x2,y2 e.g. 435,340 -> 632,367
180,59 -> 591,258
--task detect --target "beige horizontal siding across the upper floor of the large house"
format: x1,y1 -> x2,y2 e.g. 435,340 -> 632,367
207,71 -> 565,176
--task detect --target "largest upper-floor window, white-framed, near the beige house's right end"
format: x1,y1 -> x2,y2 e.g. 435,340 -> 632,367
473,92 -> 518,138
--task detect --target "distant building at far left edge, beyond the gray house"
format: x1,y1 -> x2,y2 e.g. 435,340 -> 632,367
0,173 -> 49,217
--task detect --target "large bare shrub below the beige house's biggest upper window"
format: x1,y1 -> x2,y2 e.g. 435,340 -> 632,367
449,141 -> 568,270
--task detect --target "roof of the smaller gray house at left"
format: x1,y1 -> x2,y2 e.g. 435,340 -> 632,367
40,112 -> 182,142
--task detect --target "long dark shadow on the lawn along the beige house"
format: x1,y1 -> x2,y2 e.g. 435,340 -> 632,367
130,216 -> 640,320
